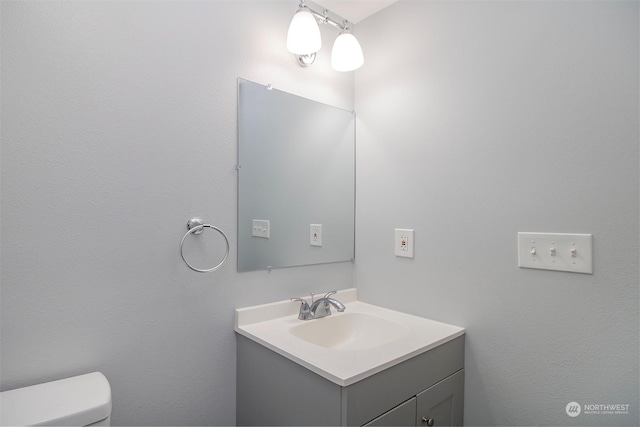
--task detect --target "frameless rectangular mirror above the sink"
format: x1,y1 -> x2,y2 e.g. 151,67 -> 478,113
238,79 -> 355,271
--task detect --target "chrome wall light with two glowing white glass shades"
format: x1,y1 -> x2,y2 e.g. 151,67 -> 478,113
287,0 -> 364,71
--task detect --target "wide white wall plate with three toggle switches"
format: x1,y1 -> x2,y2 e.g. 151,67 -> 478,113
518,232 -> 593,274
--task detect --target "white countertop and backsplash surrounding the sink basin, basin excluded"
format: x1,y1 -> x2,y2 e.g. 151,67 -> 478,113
234,288 -> 465,386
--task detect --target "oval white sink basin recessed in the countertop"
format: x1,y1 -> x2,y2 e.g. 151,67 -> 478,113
289,312 -> 409,350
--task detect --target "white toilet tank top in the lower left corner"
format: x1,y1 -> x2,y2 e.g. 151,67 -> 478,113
0,372 -> 111,426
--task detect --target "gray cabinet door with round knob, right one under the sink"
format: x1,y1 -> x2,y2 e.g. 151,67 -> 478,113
416,369 -> 464,427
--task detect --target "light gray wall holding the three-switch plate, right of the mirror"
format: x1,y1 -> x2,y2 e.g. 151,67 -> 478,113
355,0 -> 640,425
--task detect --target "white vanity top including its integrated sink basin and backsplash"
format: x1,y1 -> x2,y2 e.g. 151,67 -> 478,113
234,289 -> 465,386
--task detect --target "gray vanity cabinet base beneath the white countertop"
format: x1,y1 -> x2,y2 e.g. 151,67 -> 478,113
236,335 -> 464,426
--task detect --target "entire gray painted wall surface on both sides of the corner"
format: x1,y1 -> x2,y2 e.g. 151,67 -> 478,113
0,0 -> 639,425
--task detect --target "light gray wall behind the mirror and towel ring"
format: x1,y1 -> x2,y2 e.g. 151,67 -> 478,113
0,0 -> 354,425
